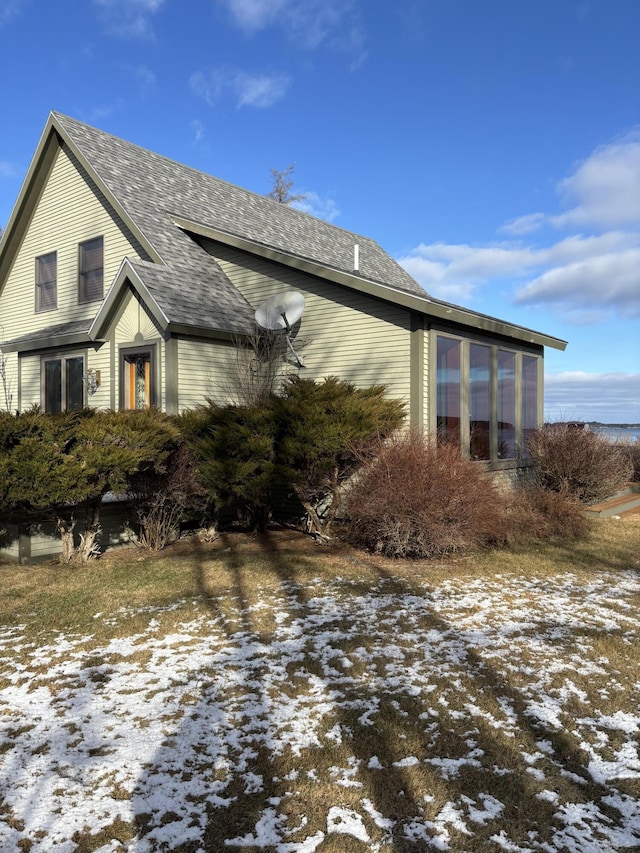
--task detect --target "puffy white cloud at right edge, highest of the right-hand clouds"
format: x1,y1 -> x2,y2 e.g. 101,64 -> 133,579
549,129 -> 640,228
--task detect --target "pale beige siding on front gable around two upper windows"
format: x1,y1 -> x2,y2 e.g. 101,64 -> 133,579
0,143 -> 143,340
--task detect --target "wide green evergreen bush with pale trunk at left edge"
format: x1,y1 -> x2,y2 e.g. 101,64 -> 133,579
0,409 -> 190,561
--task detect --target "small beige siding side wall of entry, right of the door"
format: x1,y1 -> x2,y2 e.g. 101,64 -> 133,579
178,338 -> 236,411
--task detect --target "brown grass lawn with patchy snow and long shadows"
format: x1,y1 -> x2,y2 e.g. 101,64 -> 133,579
0,518 -> 640,853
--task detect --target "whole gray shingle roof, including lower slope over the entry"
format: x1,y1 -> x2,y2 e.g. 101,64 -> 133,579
53,113 -> 427,331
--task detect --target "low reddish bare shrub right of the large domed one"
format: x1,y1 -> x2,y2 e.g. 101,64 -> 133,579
506,483 -> 591,545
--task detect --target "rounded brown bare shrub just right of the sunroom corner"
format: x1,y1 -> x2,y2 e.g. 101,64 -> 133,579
527,424 -> 633,504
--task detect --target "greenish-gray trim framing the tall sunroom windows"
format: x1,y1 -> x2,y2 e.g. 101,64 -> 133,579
429,327 -> 544,469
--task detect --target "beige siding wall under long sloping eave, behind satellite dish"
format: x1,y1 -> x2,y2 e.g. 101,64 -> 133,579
205,241 -> 410,402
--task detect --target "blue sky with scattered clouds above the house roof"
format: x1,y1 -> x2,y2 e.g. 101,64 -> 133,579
0,0 -> 640,422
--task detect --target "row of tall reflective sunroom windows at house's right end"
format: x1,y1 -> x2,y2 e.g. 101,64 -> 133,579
434,334 -> 541,461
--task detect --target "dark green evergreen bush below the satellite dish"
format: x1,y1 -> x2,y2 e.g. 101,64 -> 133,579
182,377 -> 404,533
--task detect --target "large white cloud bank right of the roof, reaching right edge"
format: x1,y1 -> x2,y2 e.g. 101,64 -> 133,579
399,130 -> 640,324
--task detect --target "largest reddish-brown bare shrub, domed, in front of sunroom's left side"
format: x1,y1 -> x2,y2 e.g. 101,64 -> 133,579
346,432 -> 506,559
